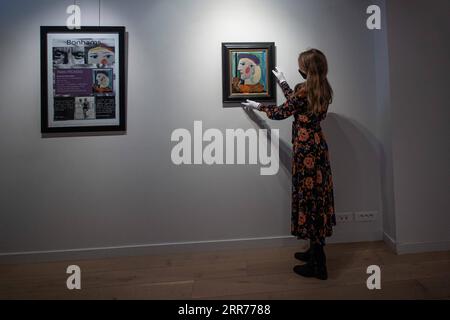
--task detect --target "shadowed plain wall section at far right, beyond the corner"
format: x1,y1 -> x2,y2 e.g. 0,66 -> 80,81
387,0 -> 450,252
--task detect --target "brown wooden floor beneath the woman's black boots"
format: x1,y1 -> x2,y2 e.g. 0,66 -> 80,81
0,242 -> 450,300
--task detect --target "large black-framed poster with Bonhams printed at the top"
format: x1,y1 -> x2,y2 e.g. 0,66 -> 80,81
41,27 -> 126,133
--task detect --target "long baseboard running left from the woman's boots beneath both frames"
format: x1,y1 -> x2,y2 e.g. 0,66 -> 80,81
0,236 -> 302,264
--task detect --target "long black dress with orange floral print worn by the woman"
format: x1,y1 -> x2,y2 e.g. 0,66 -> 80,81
260,82 -> 336,245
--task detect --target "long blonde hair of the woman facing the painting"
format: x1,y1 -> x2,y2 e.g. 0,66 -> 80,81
294,49 -> 333,114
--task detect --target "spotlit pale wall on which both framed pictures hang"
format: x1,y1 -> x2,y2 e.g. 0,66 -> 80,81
0,0 -> 386,260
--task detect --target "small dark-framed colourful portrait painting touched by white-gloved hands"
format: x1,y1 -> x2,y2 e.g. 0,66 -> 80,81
222,42 -> 277,104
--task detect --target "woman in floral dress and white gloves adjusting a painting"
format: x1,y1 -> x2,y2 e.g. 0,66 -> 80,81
243,49 -> 336,280
